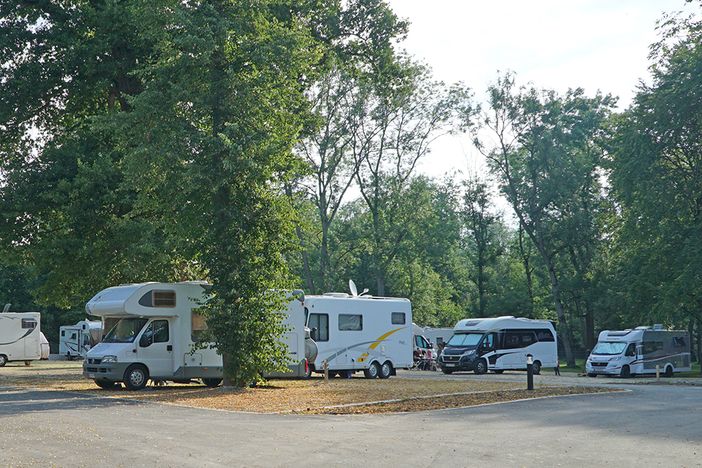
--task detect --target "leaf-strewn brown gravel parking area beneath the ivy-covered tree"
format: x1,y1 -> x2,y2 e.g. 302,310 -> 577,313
0,361 -> 616,414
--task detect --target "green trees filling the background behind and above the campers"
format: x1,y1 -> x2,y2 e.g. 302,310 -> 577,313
0,0 -> 702,372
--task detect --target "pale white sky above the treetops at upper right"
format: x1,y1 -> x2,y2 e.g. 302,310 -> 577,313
388,0 -> 699,177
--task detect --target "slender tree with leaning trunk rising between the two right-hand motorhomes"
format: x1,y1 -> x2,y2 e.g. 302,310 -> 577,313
475,75 -> 614,366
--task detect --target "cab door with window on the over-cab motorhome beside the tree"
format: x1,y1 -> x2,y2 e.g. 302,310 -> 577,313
136,318 -> 173,378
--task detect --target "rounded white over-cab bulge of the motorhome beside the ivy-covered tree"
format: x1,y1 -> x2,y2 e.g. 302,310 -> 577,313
85,281 -> 209,317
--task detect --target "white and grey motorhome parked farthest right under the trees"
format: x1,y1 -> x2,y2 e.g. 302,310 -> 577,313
585,325 -> 691,377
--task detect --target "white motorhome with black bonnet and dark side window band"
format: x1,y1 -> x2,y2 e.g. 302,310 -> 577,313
439,316 -> 558,374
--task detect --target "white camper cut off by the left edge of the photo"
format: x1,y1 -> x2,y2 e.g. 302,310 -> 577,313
0,312 -> 48,367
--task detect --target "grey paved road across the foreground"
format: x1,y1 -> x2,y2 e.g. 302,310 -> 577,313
0,373 -> 702,467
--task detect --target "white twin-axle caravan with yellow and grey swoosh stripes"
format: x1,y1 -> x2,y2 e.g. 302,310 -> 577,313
304,294 -> 413,379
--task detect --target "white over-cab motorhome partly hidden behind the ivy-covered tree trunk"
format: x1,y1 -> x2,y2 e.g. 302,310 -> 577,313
83,281 -> 310,390
